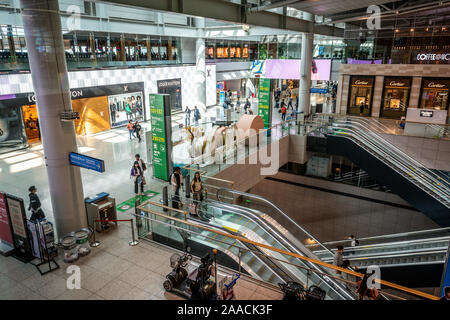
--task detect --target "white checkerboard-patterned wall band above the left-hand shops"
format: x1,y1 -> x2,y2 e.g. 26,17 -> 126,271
0,65 -> 216,106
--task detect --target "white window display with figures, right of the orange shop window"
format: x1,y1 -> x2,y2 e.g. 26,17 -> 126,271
108,92 -> 144,128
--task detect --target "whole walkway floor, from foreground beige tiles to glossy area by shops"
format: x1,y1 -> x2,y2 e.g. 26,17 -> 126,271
0,98 -> 282,300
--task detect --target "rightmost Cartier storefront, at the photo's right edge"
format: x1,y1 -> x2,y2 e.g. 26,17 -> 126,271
419,78 -> 450,110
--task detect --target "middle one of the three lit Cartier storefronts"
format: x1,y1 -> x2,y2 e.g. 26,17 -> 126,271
380,77 -> 412,119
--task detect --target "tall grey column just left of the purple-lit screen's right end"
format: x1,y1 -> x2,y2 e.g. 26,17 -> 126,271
298,12 -> 314,114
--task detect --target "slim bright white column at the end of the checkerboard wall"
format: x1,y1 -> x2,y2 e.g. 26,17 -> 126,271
194,18 -> 206,112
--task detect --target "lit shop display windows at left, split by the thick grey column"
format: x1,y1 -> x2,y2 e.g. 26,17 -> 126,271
0,82 -> 147,153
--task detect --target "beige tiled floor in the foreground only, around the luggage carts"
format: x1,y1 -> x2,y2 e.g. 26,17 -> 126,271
0,215 -> 282,300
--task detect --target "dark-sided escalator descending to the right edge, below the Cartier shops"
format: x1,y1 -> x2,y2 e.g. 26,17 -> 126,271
326,117 -> 450,227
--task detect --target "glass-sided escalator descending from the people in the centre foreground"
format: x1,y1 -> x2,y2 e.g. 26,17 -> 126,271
157,192 -> 355,300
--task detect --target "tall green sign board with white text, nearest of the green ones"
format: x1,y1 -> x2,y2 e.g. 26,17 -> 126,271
149,93 -> 171,181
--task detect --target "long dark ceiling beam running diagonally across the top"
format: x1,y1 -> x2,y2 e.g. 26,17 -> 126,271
101,0 -> 344,37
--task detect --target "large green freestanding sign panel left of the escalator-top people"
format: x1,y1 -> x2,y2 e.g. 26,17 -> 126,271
149,93 -> 172,181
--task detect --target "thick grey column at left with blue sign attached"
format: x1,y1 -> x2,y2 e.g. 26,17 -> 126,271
20,0 -> 87,237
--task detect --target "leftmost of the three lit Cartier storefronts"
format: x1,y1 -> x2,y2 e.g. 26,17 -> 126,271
347,76 -> 374,117
